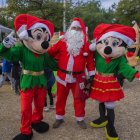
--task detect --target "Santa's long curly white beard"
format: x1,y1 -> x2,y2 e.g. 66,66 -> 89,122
65,30 -> 84,56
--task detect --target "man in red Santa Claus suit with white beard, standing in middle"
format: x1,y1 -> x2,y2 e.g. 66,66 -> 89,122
47,18 -> 95,129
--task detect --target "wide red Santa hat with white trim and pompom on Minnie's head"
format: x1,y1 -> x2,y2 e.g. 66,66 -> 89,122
90,23 -> 136,50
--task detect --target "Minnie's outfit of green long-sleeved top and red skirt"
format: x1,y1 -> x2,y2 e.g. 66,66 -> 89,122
90,51 -> 137,102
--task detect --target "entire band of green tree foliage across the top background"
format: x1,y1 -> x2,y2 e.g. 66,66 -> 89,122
0,0 -> 133,39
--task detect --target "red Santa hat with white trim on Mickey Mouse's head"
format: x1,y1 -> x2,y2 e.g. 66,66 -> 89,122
14,14 -> 54,39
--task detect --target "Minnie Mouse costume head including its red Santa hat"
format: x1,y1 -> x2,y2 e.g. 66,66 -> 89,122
90,23 -> 136,59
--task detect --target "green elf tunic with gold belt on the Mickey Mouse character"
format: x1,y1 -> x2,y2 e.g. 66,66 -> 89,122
0,44 -> 57,91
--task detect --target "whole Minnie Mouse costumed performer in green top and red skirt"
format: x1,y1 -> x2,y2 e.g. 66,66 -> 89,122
90,23 -> 140,140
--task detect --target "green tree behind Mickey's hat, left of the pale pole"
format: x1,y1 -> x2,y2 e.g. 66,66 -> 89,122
2,0 -> 63,30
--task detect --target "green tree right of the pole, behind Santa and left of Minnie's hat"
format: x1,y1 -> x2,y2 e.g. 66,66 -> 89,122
71,0 -> 114,39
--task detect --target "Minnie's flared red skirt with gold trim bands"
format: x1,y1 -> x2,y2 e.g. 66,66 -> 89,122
90,73 -> 124,102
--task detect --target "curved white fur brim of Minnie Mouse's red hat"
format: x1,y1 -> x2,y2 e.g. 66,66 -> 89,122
98,31 -> 134,47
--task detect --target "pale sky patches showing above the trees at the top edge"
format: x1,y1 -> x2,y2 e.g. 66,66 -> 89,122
0,0 -> 120,9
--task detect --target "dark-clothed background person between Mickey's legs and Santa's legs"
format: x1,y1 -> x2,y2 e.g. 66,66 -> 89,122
44,68 -> 55,112
